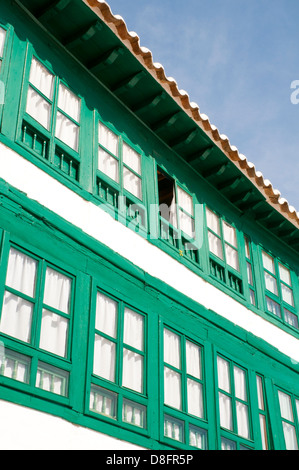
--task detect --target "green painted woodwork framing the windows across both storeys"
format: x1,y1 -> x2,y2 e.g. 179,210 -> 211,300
0,2 -> 299,449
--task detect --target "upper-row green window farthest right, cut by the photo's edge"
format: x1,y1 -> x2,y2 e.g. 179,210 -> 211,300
262,251 -> 299,329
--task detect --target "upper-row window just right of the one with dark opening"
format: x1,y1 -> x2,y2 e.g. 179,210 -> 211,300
206,208 -> 243,294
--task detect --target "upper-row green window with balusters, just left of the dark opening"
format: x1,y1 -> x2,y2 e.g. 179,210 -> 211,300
94,118 -> 147,230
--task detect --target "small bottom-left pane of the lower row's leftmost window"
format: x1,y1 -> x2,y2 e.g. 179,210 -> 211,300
0,347 -> 31,383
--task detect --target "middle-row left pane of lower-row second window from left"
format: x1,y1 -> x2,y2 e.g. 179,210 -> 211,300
93,335 -> 115,382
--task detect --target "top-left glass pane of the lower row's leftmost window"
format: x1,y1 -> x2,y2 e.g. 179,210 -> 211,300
5,248 -> 37,297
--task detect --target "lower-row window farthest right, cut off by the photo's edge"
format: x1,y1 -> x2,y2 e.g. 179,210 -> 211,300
278,390 -> 299,450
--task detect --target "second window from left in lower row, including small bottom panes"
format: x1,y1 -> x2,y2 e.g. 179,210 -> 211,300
89,291 -> 147,429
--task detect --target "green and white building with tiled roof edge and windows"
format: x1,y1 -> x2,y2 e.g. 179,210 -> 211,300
0,0 -> 299,450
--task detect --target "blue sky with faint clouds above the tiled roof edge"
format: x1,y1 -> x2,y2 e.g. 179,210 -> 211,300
107,0 -> 299,211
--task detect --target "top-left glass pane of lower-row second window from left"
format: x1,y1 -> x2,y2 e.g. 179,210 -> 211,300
95,292 -> 118,338
